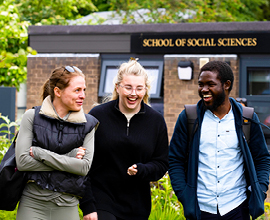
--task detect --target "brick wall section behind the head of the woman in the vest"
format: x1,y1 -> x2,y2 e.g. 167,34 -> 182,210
27,56 -> 100,113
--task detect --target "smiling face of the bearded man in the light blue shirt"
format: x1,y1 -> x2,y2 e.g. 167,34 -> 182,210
198,71 -> 228,112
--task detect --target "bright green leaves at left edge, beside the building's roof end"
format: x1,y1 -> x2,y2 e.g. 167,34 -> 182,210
0,1 -> 36,90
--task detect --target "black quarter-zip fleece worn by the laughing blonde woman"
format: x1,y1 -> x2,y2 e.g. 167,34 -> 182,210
80,100 -> 168,220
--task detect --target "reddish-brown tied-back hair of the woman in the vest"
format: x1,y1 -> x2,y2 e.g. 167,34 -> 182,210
41,66 -> 85,101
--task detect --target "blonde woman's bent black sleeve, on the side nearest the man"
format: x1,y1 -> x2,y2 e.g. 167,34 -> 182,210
136,118 -> 169,182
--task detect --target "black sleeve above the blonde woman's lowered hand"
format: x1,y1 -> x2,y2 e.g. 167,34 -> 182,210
80,174 -> 97,216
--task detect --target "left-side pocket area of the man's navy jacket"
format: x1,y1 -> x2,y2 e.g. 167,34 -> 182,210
179,185 -> 199,220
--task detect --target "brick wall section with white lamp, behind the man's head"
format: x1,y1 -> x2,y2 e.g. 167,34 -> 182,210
164,56 -> 239,139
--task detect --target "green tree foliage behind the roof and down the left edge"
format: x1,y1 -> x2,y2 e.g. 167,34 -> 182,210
0,0 -> 270,89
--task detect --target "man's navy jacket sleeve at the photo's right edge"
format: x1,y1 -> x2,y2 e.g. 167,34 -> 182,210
249,113 -> 270,192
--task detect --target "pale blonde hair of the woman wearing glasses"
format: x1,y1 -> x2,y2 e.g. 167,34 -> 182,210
110,58 -> 151,105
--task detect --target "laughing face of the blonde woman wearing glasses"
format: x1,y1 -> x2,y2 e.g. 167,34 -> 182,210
116,75 -> 146,114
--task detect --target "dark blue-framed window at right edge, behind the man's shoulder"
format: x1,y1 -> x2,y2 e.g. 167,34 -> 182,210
239,55 -> 270,151
